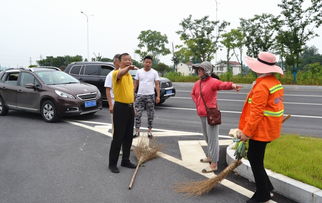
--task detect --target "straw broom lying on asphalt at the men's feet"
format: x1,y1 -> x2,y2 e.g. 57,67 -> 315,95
129,137 -> 160,190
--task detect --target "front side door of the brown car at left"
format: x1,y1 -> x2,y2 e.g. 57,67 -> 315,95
17,72 -> 40,111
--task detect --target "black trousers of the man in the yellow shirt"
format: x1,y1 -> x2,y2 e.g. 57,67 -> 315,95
109,102 -> 134,166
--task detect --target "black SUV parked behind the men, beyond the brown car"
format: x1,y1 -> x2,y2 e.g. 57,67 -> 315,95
65,62 -> 176,104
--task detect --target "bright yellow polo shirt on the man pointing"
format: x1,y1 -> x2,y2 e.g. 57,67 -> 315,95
112,70 -> 134,104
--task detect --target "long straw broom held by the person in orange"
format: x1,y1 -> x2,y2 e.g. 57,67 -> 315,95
175,114 -> 291,196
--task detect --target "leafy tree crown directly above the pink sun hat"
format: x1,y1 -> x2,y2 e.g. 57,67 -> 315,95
240,13 -> 281,57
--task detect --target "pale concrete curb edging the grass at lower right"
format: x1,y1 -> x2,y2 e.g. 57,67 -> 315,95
226,143 -> 322,203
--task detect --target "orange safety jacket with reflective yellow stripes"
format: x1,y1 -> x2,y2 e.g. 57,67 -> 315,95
239,75 -> 284,142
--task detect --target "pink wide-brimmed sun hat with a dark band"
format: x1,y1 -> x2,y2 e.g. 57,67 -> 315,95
245,52 -> 283,75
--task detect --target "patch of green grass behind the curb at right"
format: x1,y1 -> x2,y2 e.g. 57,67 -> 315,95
265,134 -> 322,189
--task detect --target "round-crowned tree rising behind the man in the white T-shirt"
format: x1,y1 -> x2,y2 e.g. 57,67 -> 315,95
135,30 -> 170,61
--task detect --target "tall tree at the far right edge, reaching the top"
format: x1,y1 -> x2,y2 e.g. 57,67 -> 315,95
278,0 -> 322,82
